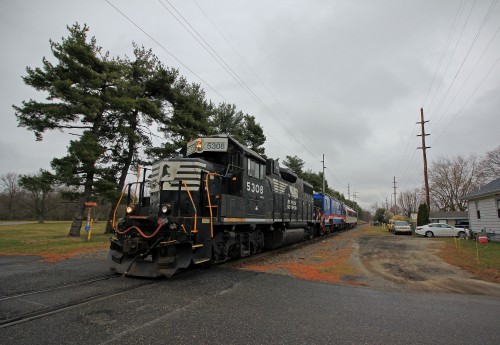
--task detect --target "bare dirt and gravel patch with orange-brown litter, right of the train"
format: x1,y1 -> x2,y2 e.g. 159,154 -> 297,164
238,226 -> 500,297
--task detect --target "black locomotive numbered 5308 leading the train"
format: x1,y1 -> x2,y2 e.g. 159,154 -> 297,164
109,135 -> 356,277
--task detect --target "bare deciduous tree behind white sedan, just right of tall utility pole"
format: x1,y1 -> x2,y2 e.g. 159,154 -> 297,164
429,155 -> 484,211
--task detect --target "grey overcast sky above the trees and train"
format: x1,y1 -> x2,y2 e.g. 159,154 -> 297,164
0,0 -> 500,209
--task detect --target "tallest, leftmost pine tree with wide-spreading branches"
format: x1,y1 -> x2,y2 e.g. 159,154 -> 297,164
14,24 -> 123,237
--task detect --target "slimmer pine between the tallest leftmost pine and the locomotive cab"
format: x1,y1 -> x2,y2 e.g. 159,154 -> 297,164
103,44 -> 178,233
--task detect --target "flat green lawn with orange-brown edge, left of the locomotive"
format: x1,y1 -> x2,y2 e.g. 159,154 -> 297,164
0,222 -> 111,261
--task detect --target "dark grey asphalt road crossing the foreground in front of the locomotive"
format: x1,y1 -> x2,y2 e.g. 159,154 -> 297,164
0,250 -> 500,345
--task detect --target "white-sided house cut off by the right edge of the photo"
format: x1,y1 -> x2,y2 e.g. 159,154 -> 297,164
463,178 -> 500,234
